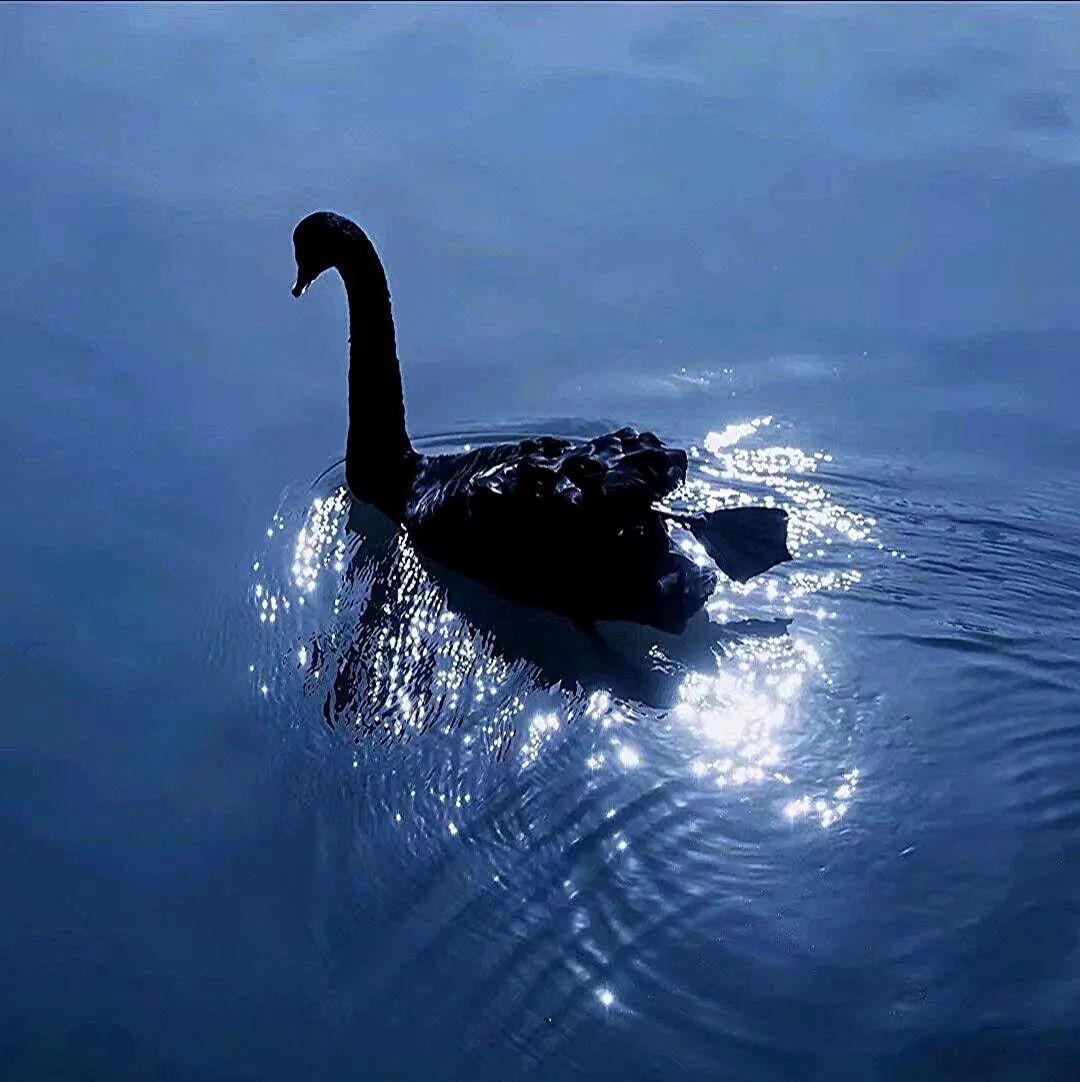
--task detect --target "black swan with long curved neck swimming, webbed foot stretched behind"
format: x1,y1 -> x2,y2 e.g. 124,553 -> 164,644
292,211 -> 791,634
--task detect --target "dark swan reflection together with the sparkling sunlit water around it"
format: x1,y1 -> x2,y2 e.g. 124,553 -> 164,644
251,418 -> 881,833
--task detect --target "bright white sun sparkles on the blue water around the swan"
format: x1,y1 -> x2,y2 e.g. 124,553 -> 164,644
251,417 -> 881,835
